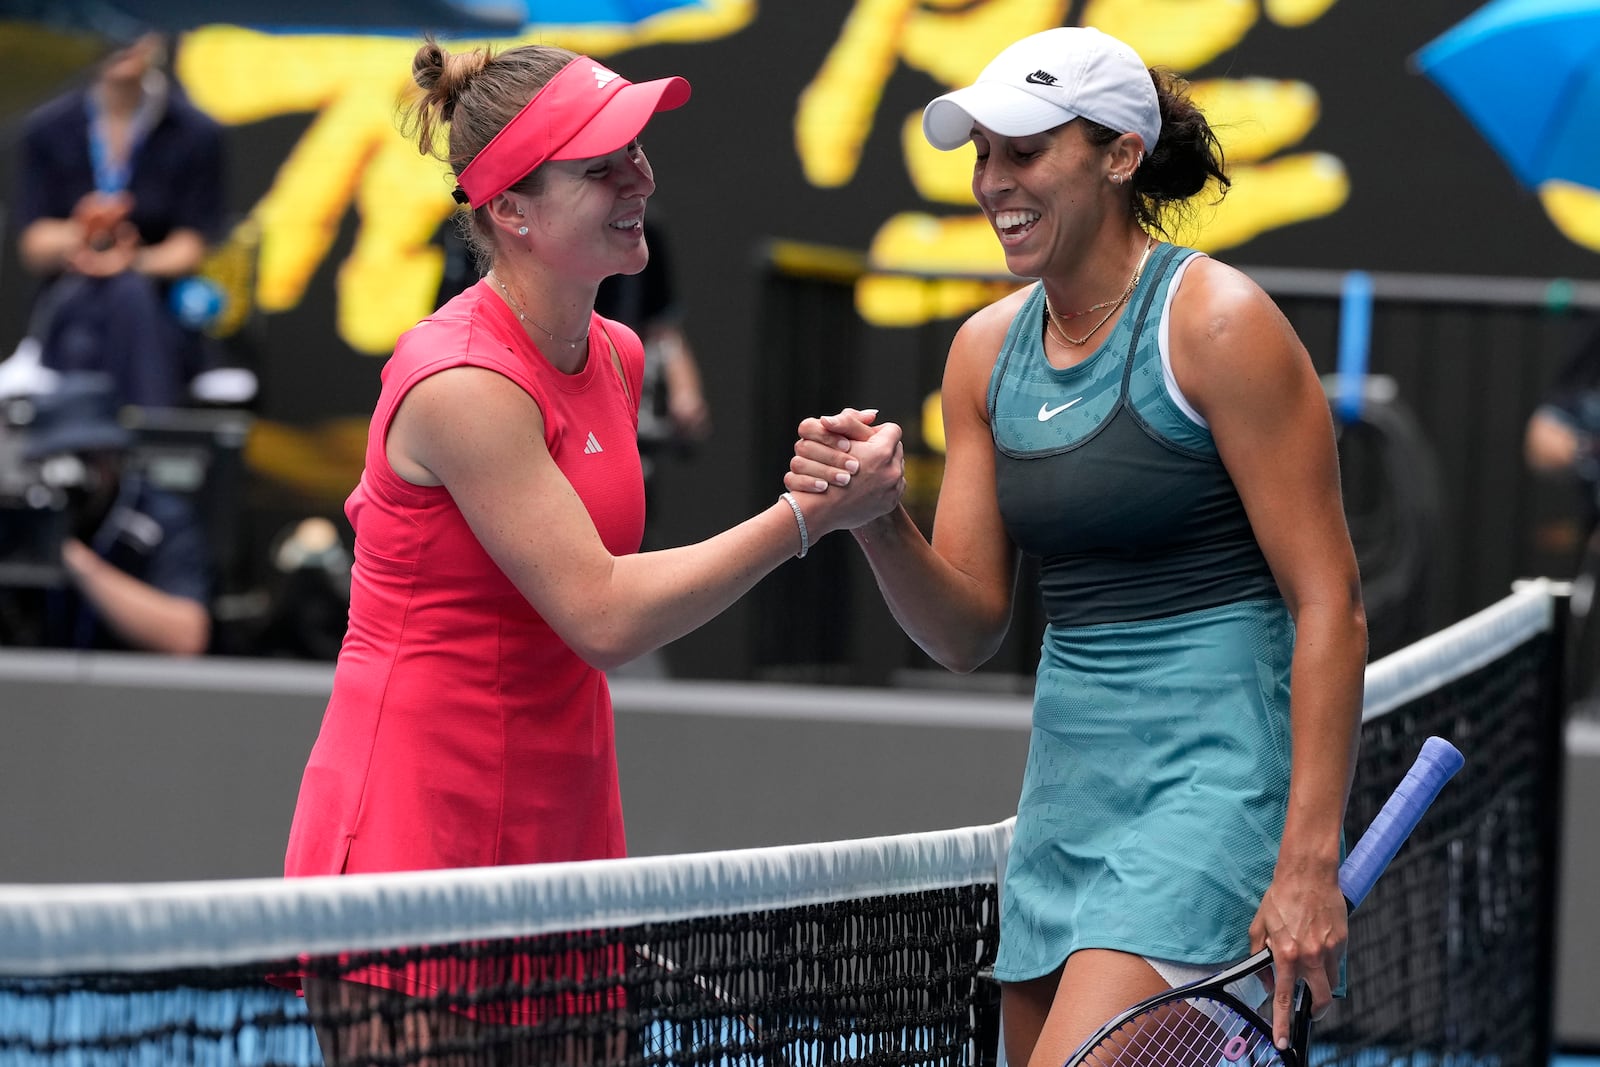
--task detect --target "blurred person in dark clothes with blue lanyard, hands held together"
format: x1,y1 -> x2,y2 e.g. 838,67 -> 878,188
11,34 -> 224,408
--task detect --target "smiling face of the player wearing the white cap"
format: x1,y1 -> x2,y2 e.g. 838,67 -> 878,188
973,122 -> 1138,278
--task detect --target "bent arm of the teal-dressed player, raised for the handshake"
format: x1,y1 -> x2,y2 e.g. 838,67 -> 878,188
786,306 -> 1018,673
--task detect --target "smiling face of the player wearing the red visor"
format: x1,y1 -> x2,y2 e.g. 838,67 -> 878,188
523,139 -> 656,285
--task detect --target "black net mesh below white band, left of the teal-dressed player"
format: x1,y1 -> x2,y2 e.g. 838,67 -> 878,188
0,885 -> 998,1067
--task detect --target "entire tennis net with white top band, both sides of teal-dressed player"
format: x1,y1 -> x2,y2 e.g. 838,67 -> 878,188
0,585 -> 1560,1067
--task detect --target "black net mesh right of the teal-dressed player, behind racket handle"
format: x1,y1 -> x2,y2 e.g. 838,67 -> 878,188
1312,633 -> 1562,1067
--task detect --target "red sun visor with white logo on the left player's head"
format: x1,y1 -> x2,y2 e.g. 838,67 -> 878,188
456,56 -> 690,210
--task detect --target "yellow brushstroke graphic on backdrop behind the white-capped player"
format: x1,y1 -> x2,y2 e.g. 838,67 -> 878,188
795,0 -> 1349,326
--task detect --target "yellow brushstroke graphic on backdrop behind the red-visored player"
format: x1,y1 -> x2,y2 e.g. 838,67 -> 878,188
178,0 -> 755,355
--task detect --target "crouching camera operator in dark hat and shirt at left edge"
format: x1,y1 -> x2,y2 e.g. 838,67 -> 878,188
0,373 -> 211,656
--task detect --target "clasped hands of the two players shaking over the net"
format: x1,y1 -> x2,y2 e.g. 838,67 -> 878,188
784,408 -> 906,531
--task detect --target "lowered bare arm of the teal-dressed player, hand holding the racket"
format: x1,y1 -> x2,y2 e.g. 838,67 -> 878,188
1170,259 -> 1366,1037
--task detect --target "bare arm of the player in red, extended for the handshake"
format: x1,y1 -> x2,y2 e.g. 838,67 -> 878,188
386,366 -> 904,669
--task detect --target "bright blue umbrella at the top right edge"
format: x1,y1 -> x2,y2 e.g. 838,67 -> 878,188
1414,0 -> 1600,189
